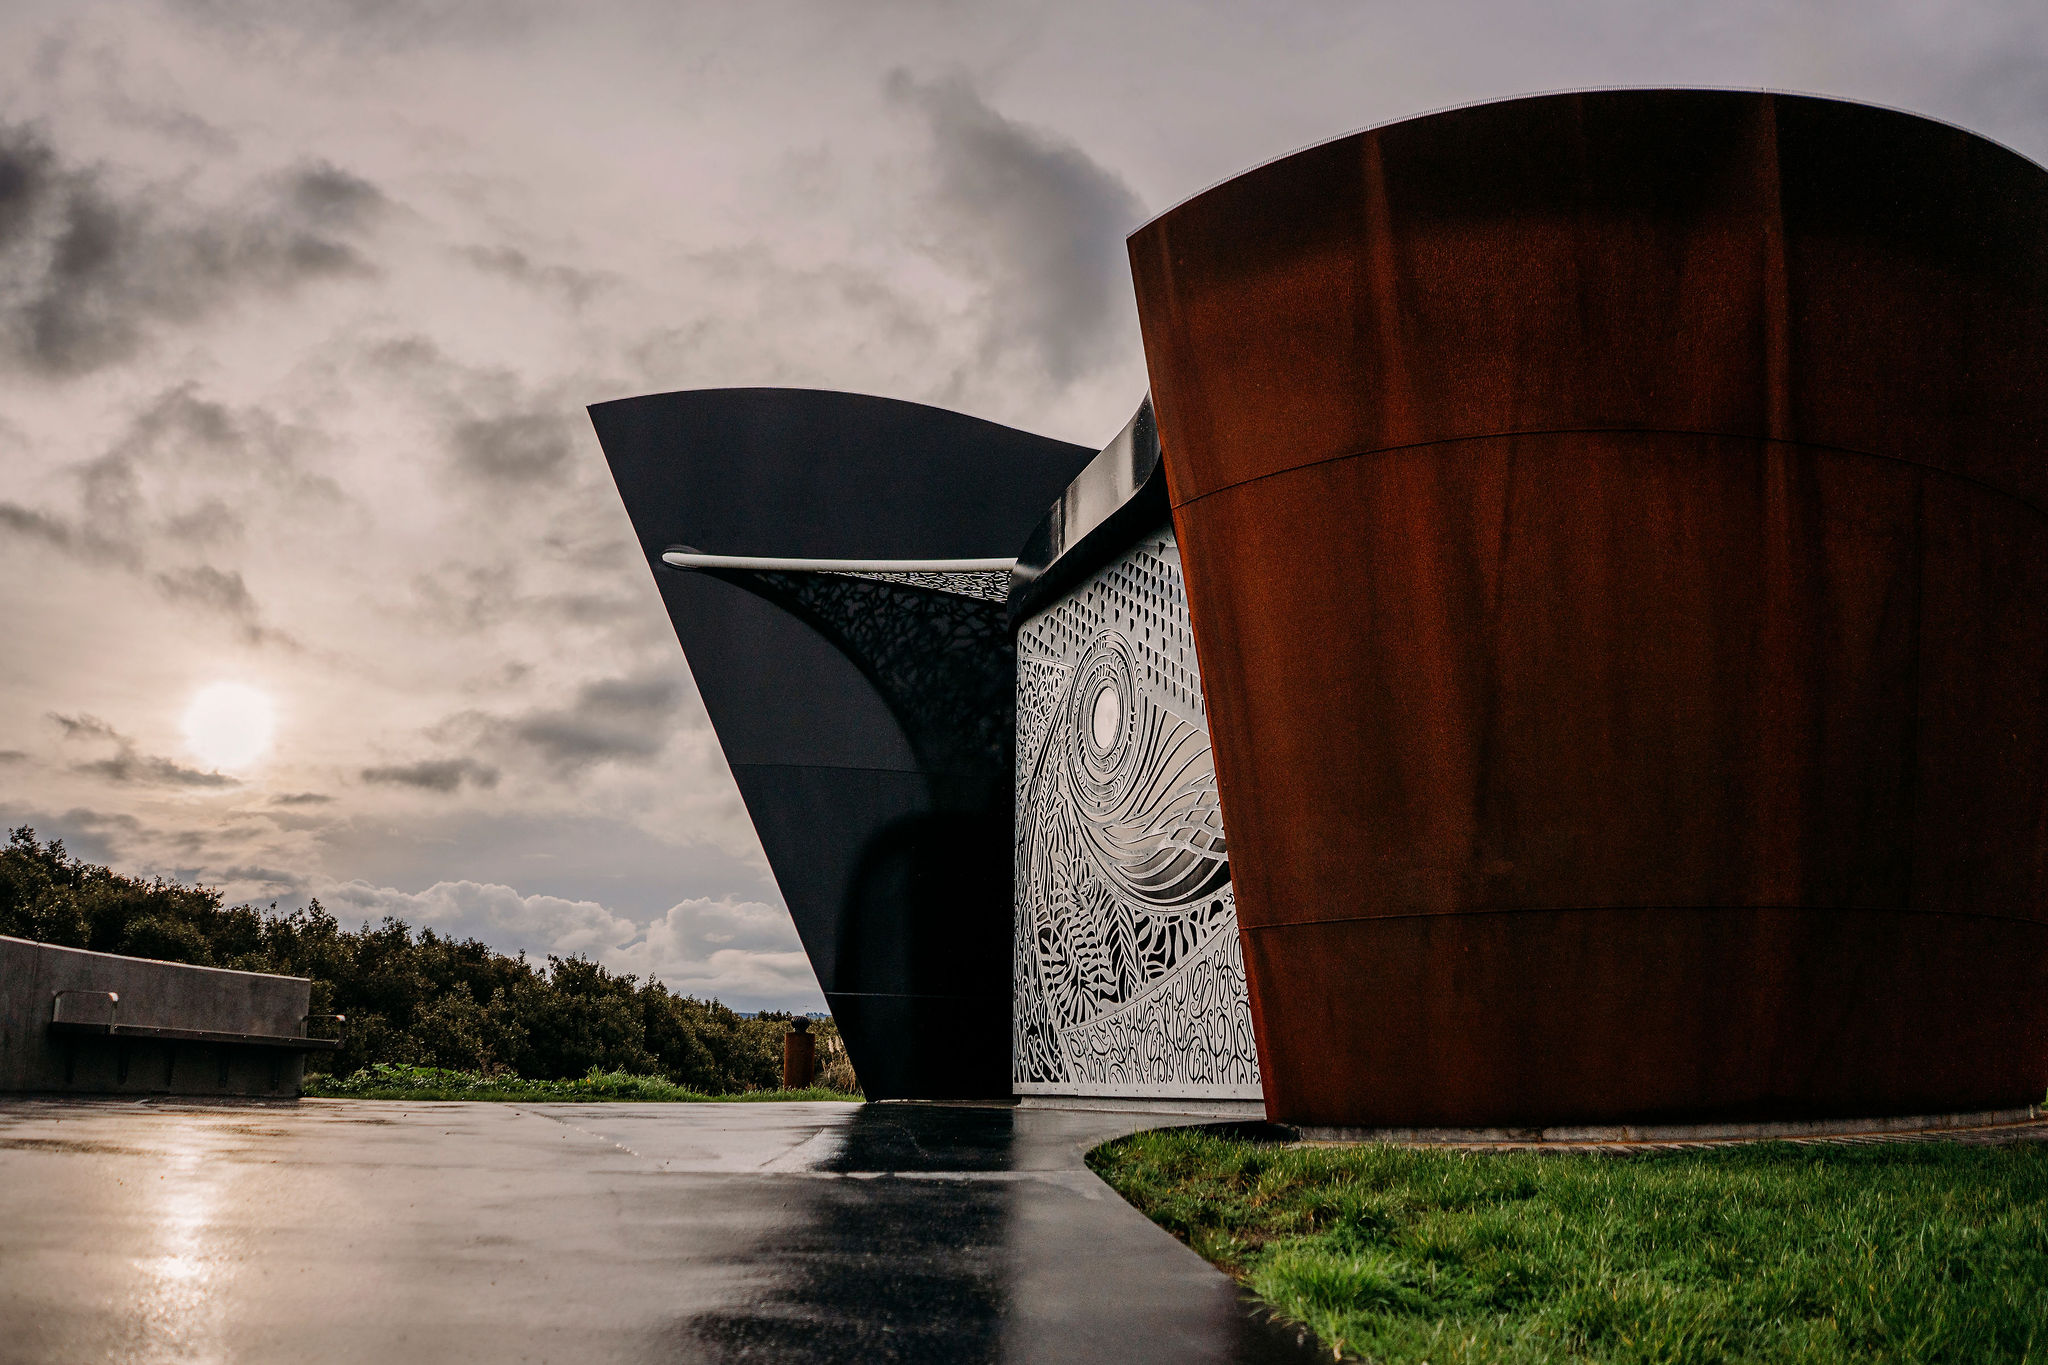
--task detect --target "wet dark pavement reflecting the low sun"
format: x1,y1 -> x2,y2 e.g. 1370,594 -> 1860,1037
0,1099 -> 1325,1365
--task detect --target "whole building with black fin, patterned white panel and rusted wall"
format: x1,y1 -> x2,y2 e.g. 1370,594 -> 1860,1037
596,90 -> 2048,1134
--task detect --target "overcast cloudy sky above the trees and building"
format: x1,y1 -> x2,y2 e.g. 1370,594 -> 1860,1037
0,0 -> 2048,1007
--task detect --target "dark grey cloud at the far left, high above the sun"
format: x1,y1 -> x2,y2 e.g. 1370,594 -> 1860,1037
0,125 -> 385,375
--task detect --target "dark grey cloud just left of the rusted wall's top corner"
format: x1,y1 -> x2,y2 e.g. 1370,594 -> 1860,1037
889,72 -> 1145,383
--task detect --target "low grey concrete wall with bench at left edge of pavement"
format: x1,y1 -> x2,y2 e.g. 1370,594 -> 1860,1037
0,937 -> 313,1095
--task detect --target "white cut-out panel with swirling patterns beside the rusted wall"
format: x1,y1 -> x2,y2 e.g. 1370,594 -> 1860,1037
1012,534 -> 1262,1099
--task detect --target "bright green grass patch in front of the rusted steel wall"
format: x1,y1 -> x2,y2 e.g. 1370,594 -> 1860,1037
1087,1130 -> 2048,1365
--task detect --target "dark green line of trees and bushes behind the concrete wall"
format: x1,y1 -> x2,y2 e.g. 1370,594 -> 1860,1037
0,827 -> 854,1095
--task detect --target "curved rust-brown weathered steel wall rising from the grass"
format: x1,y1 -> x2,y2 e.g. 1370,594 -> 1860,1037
1130,92 -> 2048,1126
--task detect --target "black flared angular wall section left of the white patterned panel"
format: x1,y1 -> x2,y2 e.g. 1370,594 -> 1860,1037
590,389 -> 1096,1099
